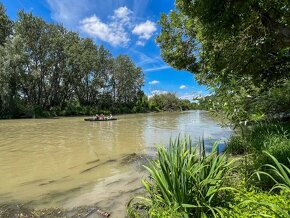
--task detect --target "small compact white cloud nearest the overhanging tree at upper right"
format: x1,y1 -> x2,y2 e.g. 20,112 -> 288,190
132,20 -> 157,40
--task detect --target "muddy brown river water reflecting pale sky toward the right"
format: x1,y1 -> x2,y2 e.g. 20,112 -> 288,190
0,111 -> 231,215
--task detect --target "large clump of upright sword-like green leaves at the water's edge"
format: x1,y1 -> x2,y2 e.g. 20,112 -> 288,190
143,139 -> 232,217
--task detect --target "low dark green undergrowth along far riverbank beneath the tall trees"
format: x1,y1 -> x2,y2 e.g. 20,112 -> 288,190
0,93 -> 195,119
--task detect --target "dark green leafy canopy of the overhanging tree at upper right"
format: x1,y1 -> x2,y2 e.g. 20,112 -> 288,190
157,0 -> 290,85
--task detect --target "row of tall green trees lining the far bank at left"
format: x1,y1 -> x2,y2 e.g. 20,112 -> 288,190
0,4 -> 144,118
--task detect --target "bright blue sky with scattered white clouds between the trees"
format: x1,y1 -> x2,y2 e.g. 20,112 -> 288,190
0,0 -> 207,99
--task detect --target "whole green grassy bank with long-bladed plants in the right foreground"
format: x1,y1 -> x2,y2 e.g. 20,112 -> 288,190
128,123 -> 290,217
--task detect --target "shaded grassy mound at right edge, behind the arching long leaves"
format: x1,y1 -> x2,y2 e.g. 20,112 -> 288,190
227,123 -> 290,168
